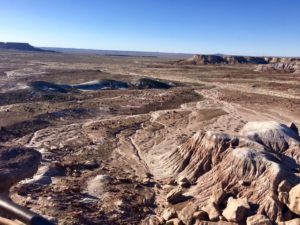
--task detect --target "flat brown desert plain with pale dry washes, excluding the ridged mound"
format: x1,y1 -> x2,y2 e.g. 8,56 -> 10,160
0,52 -> 300,225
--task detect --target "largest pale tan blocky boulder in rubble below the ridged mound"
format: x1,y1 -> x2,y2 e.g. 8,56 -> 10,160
223,197 -> 250,222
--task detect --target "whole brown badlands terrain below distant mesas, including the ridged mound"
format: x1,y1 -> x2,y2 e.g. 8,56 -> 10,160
0,52 -> 300,225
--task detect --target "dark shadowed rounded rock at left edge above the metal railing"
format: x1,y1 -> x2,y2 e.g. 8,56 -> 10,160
0,146 -> 41,192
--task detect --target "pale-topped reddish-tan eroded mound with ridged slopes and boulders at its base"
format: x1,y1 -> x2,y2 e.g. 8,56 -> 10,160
159,121 -> 300,223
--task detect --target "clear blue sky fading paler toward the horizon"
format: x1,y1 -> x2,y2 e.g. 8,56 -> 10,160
0,0 -> 300,56
